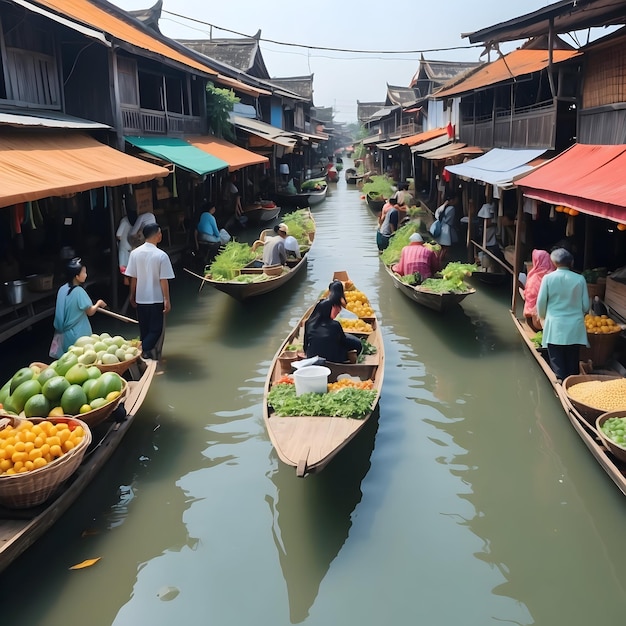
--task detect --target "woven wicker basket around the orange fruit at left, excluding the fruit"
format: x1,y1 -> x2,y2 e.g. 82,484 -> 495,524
0,417 -> 91,509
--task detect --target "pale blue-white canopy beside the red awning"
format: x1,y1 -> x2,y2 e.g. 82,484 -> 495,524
445,148 -> 546,189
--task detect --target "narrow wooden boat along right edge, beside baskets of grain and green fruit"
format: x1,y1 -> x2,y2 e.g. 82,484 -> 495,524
511,313 -> 626,495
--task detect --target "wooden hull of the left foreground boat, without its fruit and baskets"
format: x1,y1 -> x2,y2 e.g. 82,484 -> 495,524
0,359 -> 157,571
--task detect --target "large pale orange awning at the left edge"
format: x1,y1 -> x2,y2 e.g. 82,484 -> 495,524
0,131 -> 169,207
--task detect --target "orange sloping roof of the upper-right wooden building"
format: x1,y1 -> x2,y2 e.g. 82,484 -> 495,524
435,50 -> 580,99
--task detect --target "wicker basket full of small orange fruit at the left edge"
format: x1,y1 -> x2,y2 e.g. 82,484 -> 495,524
0,414 -> 91,509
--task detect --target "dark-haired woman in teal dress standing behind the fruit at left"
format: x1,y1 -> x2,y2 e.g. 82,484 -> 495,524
51,258 -> 106,358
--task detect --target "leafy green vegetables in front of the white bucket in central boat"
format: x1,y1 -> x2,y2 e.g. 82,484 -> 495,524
267,383 -> 376,419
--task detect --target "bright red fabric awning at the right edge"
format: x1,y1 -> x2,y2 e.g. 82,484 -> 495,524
514,144 -> 626,222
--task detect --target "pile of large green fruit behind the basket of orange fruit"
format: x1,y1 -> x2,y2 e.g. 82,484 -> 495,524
0,351 -> 126,419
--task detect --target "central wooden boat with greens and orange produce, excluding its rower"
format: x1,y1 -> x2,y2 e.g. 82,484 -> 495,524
263,272 -> 385,477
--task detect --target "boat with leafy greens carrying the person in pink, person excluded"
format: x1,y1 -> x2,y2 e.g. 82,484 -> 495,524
380,223 -> 478,311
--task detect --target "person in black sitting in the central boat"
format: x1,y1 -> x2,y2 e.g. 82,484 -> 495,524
304,280 -> 363,363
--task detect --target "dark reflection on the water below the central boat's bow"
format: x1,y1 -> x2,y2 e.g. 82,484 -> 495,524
268,410 -> 378,624
